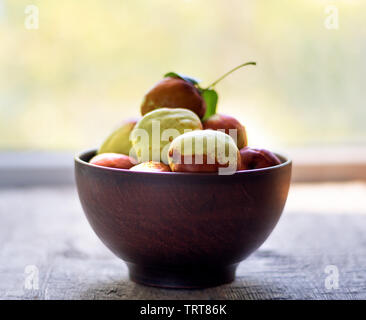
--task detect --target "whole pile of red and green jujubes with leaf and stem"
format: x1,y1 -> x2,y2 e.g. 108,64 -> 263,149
89,62 -> 281,172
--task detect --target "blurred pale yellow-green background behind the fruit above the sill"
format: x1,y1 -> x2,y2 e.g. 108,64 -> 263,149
0,0 -> 366,150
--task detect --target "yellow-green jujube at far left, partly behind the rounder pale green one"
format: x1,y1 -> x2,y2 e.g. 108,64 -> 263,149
98,119 -> 138,155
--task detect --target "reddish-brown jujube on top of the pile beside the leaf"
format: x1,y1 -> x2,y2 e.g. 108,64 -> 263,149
141,77 -> 206,119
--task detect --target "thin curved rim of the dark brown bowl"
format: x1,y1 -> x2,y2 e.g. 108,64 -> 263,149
74,149 -> 292,177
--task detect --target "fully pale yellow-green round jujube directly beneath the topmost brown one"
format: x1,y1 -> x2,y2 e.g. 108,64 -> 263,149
130,108 -> 202,164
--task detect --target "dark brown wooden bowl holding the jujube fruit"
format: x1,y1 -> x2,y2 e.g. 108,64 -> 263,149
75,150 -> 291,288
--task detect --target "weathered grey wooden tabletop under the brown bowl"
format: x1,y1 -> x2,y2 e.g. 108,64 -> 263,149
0,183 -> 366,299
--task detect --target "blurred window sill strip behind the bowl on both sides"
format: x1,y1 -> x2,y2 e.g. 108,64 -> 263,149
0,147 -> 366,187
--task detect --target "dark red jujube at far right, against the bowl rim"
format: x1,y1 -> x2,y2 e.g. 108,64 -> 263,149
240,147 -> 281,170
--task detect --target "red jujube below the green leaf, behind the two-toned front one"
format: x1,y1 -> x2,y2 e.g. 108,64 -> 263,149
202,113 -> 248,149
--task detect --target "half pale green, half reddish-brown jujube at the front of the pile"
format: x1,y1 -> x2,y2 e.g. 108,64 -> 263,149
168,130 -> 241,174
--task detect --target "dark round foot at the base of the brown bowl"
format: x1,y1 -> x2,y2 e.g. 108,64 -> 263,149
127,263 -> 237,289
